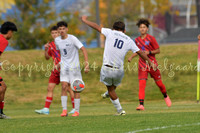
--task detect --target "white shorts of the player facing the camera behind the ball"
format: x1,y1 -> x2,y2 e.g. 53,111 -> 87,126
60,68 -> 82,83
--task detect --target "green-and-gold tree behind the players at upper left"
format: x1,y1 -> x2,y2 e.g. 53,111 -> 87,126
4,0 -> 84,49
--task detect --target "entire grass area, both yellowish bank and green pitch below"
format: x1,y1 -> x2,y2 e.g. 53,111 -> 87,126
0,44 -> 200,133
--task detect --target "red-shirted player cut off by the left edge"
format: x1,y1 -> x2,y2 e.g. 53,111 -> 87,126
0,22 -> 17,119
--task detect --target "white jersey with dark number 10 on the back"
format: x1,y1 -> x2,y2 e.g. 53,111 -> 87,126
101,28 -> 140,68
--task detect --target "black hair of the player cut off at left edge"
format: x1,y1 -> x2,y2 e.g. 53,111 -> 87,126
0,21 -> 17,34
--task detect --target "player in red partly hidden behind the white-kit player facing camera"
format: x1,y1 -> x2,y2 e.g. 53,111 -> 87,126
35,26 -> 75,114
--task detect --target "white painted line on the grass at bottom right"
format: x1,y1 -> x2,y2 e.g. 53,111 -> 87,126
128,123 -> 200,133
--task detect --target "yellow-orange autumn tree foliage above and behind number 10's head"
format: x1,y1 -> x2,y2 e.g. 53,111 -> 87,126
88,0 -> 171,44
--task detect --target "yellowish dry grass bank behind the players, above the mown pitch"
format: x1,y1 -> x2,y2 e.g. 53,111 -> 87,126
0,44 -> 198,104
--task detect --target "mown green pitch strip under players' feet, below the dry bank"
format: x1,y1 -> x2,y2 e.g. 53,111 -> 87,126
0,99 -> 200,133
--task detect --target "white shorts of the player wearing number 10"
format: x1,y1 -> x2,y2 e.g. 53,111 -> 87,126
100,65 -> 124,86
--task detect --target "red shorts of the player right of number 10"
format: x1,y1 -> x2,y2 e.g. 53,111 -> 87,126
138,68 -> 161,80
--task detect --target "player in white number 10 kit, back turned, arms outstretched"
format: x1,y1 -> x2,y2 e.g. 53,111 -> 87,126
82,16 -> 156,115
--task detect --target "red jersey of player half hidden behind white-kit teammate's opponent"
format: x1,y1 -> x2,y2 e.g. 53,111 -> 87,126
48,42 -> 60,74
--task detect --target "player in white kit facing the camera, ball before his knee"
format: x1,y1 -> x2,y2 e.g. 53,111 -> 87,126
55,21 -> 89,117
